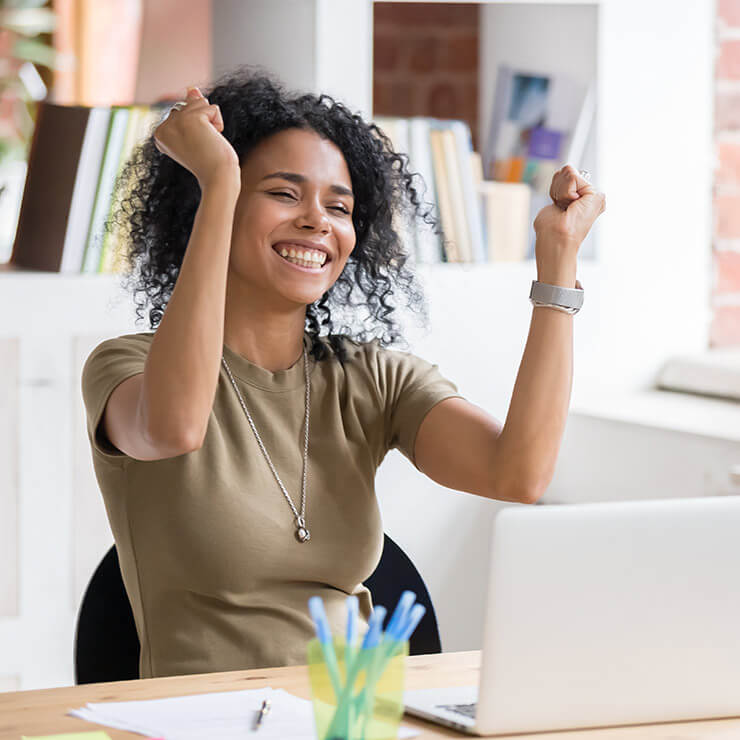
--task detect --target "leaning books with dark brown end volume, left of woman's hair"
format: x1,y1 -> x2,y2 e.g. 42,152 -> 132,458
10,102 -> 165,273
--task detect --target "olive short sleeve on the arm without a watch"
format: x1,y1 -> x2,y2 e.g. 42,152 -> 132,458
82,334 -> 152,460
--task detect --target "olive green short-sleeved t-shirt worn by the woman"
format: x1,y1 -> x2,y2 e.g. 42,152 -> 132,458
82,332 -> 459,678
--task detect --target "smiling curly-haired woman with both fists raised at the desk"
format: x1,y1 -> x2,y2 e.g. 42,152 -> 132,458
83,66 -> 604,677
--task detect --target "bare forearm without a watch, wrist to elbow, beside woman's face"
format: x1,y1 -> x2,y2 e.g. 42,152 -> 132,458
139,177 -> 239,447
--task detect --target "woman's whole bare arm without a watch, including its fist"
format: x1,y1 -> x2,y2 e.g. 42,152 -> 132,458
101,85 -> 240,460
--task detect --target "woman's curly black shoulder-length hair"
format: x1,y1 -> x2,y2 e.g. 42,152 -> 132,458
106,66 -> 442,362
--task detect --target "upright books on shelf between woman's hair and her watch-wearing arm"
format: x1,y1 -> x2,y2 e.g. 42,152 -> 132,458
374,116 -> 531,263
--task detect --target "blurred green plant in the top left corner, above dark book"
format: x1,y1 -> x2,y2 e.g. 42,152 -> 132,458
0,0 -> 56,164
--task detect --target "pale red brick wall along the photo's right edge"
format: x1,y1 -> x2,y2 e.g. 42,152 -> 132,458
711,0 -> 740,347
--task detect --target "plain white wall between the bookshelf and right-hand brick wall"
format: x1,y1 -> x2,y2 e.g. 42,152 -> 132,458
588,0 -> 714,388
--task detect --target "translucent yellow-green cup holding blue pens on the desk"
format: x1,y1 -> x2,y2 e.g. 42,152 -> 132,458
308,638 -> 409,740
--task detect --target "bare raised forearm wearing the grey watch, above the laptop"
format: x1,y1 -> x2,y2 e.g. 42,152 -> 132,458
497,254 -> 576,501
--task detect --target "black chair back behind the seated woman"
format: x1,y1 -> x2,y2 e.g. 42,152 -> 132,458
74,535 -> 442,684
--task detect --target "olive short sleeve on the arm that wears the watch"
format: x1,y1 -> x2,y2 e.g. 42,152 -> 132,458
364,345 -> 462,466
